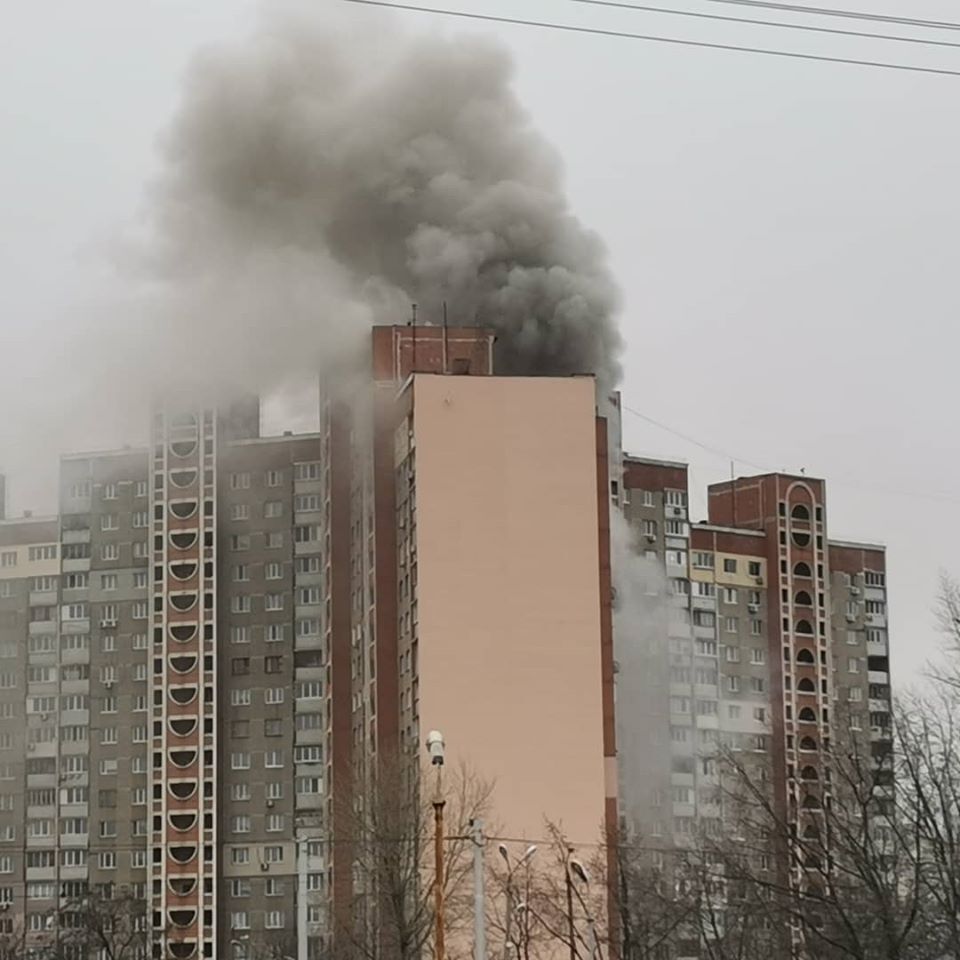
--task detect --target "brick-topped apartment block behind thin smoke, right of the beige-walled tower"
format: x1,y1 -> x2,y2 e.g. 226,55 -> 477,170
617,456 -> 891,860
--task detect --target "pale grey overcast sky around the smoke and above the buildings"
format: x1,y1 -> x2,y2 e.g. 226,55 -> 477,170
0,0 -> 960,679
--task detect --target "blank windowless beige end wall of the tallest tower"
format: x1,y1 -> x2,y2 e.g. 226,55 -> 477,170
413,375 -> 605,843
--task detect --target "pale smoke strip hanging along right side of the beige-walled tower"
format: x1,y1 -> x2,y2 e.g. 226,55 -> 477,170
610,510 -> 671,831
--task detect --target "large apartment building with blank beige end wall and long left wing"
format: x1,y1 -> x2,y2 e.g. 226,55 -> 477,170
0,328 -> 617,960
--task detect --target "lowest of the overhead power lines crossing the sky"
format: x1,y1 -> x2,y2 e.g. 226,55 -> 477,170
343,0 -> 960,77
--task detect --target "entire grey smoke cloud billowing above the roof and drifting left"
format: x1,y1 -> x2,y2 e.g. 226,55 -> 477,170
0,0 -> 620,506
